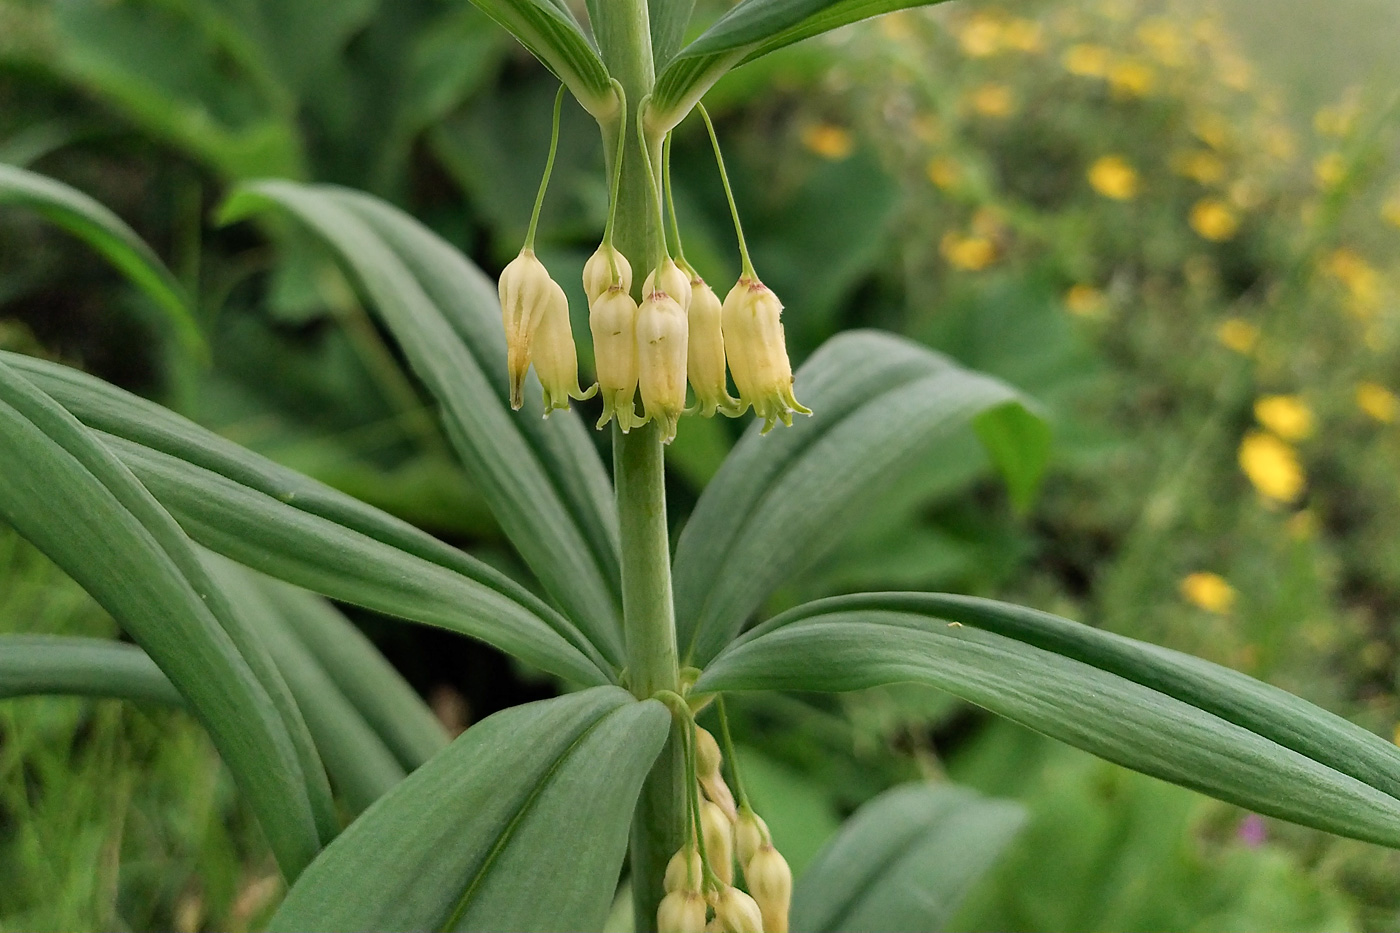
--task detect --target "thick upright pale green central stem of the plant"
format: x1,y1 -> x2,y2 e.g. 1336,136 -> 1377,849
592,0 -> 686,933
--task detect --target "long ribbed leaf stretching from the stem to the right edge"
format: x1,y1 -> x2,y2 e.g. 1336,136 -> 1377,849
696,593 -> 1400,848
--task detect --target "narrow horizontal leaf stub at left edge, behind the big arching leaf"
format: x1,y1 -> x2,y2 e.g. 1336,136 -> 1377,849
0,635 -> 183,706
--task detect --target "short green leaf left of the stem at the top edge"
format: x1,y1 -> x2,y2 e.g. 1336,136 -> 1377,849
472,0 -> 619,120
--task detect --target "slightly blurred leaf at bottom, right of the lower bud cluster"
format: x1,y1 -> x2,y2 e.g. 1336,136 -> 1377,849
792,785 -> 1026,933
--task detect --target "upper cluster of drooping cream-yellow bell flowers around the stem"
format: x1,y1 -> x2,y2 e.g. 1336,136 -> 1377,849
500,97 -> 811,443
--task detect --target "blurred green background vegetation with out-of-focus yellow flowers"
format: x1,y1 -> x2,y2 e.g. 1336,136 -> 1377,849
0,0 -> 1400,930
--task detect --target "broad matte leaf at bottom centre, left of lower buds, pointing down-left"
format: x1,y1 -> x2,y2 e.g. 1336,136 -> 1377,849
272,686 -> 671,930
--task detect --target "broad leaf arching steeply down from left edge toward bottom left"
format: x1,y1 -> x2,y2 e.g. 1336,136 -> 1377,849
0,364 -> 322,878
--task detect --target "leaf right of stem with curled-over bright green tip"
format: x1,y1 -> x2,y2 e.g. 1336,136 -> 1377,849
675,331 -> 1046,665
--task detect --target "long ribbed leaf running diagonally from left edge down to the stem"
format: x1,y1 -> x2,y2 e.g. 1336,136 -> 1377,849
0,353 -> 608,684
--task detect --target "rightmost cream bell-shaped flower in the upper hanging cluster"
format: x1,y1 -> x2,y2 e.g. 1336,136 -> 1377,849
721,276 -> 812,434
